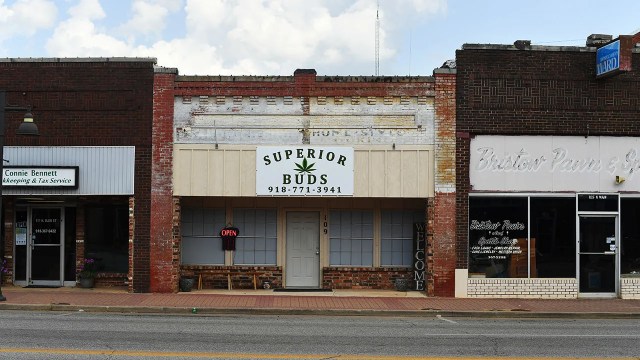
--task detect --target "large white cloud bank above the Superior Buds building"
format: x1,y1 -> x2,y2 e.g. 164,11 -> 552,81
42,0 -> 446,75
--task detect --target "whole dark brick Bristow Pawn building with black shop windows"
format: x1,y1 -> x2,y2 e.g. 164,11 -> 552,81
456,35 -> 640,298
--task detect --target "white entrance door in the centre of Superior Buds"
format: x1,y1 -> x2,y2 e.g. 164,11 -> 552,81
286,211 -> 320,288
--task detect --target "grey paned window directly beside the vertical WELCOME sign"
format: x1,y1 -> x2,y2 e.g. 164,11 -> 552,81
380,210 -> 425,266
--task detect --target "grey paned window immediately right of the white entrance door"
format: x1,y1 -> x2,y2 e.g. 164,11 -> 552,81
329,210 -> 373,266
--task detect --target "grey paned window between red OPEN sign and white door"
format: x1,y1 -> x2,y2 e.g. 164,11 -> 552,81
233,209 -> 278,265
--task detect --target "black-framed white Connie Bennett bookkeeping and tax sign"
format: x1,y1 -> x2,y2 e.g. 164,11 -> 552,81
2,166 -> 78,188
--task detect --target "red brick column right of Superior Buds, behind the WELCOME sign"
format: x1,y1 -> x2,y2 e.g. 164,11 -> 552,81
427,69 -> 457,296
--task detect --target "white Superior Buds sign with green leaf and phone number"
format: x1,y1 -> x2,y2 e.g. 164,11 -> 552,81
256,146 -> 353,196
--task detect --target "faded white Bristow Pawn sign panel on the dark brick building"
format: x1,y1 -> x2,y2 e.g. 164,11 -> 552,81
469,135 -> 640,192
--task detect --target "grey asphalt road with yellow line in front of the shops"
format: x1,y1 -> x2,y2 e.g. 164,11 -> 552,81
0,311 -> 640,359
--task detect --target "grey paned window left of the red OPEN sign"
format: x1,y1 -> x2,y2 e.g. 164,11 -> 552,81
181,208 -> 225,265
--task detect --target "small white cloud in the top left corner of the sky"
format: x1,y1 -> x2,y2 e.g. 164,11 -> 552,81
0,0 -> 58,41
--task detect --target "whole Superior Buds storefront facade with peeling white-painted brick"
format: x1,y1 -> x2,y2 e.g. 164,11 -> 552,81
151,69 -> 455,295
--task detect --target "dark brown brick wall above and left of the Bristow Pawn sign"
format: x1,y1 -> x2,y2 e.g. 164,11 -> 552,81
456,45 -> 640,268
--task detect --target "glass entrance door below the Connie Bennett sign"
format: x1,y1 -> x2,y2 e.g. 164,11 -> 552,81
27,207 -> 64,286
